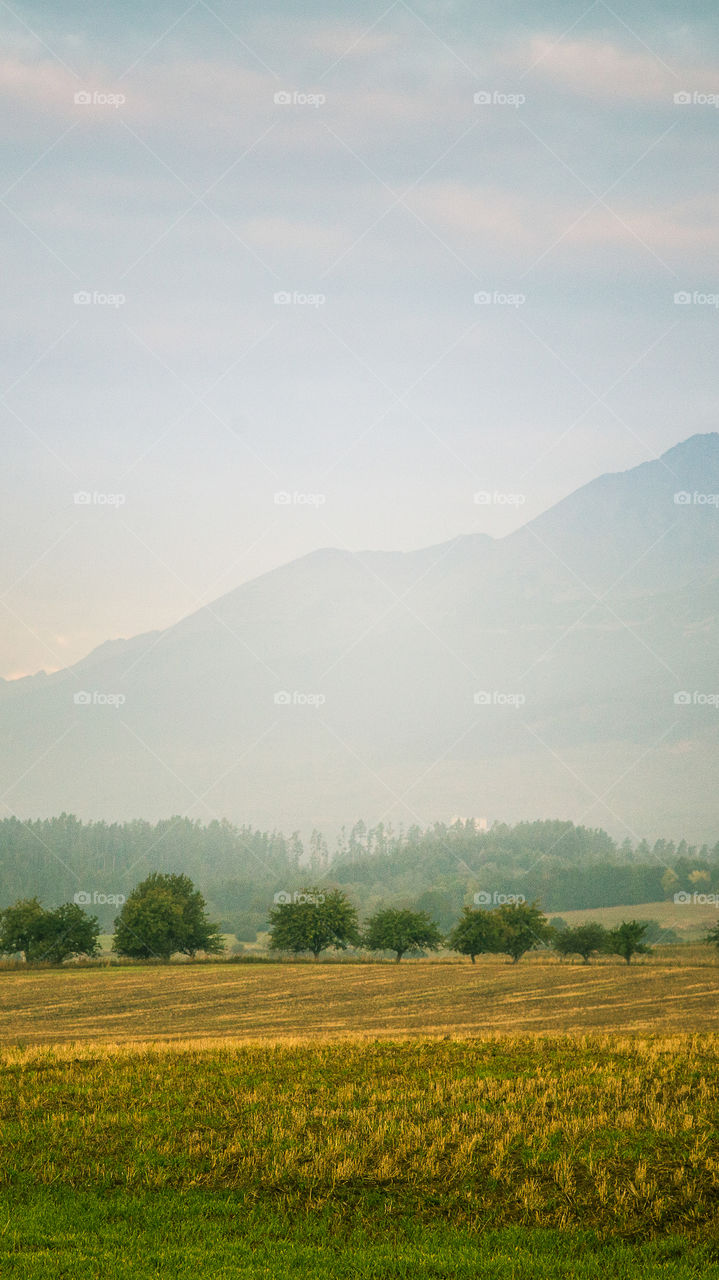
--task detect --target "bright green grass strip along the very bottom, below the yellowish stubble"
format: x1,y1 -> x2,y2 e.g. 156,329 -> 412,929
0,1188 -> 719,1280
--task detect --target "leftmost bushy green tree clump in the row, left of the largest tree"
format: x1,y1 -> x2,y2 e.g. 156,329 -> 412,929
0,897 -> 100,964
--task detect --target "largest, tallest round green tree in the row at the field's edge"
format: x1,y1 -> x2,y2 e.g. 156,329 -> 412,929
113,872 -> 224,960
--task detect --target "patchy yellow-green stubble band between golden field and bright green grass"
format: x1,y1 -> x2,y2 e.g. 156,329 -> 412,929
0,1036 -> 719,1235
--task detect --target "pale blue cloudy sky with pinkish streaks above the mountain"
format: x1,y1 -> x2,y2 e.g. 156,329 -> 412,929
0,0 -> 719,678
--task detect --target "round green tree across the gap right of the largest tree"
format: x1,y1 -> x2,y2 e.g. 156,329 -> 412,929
270,887 -> 360,960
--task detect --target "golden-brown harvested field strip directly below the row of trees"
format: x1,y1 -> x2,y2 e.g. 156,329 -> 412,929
0,946 -> 719,1046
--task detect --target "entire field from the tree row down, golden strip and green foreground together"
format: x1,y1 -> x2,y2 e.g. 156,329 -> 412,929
0,946 -> 719,1280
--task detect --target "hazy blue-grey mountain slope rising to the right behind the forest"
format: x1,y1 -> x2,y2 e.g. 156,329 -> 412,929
0,433 -> 719,841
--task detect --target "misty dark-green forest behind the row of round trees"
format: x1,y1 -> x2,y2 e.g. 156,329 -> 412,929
0,814 -> 719,942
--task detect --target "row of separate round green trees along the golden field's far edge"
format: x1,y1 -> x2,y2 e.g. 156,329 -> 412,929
0,872 -> 706,964
